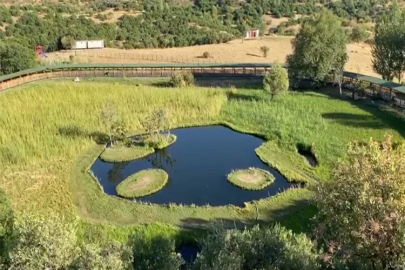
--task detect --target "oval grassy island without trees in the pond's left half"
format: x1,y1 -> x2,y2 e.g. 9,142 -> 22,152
116,169 -> 169,199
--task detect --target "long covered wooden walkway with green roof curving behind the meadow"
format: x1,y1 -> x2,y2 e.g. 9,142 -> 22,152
0,63 -> 405,108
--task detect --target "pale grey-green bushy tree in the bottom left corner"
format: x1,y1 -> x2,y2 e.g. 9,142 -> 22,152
7,215 -> 77,270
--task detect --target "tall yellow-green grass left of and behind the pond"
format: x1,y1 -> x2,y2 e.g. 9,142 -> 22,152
0,80 -> 226,213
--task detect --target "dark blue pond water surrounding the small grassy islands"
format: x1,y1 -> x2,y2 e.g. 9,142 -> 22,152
91,126 -> 291,206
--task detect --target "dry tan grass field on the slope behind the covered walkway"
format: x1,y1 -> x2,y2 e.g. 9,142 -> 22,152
47,36 -> 379,77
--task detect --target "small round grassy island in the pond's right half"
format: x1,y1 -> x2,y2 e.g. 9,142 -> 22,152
227,168 -> 275,190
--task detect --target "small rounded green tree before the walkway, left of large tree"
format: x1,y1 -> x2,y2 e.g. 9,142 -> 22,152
263,64 -> 290,99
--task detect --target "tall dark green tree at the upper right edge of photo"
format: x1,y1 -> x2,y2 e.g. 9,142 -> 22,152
371,2 -> 405,82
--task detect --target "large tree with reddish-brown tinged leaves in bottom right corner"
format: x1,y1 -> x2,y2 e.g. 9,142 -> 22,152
315,136 -> 405,269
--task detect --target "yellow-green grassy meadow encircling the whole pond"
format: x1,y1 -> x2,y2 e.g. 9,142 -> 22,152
0,79 -> 405,239
